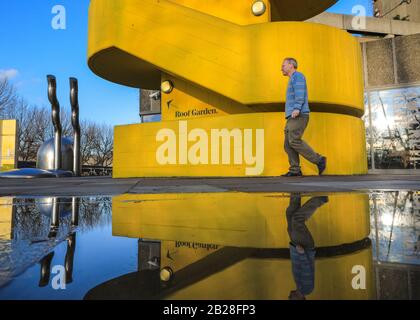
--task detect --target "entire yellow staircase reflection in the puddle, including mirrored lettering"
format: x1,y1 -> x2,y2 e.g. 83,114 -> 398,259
109,192 -> 375,300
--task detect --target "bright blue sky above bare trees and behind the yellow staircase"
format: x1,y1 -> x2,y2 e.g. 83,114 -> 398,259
0,0 -> 372,125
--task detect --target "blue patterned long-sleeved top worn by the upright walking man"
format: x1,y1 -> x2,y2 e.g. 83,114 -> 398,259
285,71 -> 310,118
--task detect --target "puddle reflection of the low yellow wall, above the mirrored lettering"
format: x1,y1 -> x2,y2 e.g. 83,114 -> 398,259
112,192 -> 370,248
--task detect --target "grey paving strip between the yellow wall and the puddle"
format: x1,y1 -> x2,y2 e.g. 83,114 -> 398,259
0,174 -> 420,197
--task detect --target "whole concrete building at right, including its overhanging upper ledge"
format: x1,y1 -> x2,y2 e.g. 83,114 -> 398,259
308,0 -> 420,173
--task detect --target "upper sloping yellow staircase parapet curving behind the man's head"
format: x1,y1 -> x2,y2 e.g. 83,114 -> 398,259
88,0 -> 364,114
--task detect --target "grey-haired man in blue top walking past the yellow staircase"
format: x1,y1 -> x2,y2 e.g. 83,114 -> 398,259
282,58 -> 327,177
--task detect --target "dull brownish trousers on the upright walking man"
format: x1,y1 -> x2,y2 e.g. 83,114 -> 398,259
284,114 -> 322,173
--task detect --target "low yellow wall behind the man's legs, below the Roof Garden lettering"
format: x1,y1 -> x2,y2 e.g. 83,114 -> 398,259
113,113 -> 367,178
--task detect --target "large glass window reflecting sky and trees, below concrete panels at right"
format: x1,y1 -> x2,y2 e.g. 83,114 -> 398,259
364,86 -> 420,169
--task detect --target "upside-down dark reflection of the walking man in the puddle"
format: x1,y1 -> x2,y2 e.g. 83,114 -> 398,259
286,194 -> 328,300
